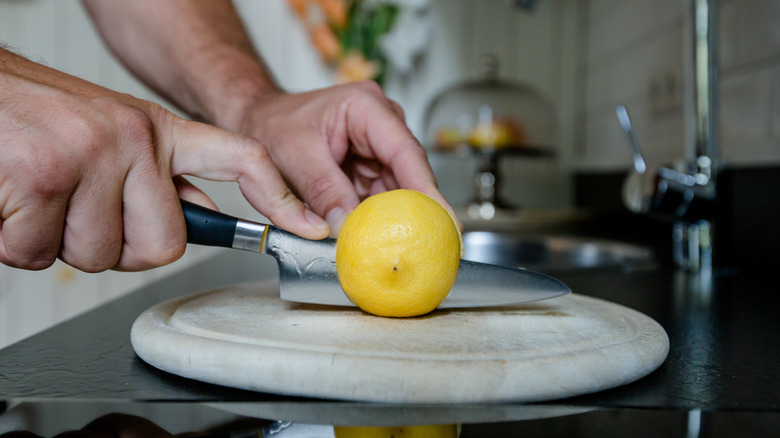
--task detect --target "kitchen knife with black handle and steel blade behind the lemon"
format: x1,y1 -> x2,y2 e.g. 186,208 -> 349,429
181,200 -> 571,308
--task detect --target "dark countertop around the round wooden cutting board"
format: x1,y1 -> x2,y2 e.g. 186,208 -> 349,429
0,251 -> 780,432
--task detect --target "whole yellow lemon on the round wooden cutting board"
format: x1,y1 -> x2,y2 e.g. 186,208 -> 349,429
336,189 -> 462,317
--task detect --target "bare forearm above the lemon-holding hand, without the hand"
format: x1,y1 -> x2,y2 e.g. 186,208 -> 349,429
84,0 -> 279,130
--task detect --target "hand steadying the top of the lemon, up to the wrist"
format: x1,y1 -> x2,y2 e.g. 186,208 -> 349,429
233,82 -> 451,235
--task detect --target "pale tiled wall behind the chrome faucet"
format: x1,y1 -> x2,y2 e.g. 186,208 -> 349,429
574,0 -> 780,170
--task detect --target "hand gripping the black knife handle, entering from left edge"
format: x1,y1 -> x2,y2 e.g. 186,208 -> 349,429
0,50 -> 329,272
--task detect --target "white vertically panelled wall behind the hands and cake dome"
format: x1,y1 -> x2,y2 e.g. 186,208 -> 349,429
0,0 -> 585,347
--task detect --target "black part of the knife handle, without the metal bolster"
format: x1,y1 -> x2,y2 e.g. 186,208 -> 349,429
180,199 -> 238,248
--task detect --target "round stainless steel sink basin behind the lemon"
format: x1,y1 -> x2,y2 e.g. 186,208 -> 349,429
463,231 -> 655,272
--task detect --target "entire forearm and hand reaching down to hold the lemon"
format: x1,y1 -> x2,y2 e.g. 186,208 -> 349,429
77,0 -> 448,236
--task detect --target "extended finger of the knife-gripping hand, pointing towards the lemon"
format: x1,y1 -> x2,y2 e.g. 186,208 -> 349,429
166,119 -> 330,239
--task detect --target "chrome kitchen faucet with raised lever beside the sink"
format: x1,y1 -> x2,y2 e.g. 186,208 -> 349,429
615,0 -> 719,272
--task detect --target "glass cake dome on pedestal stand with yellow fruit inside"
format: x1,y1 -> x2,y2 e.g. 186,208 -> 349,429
423,56 -> 555,220
